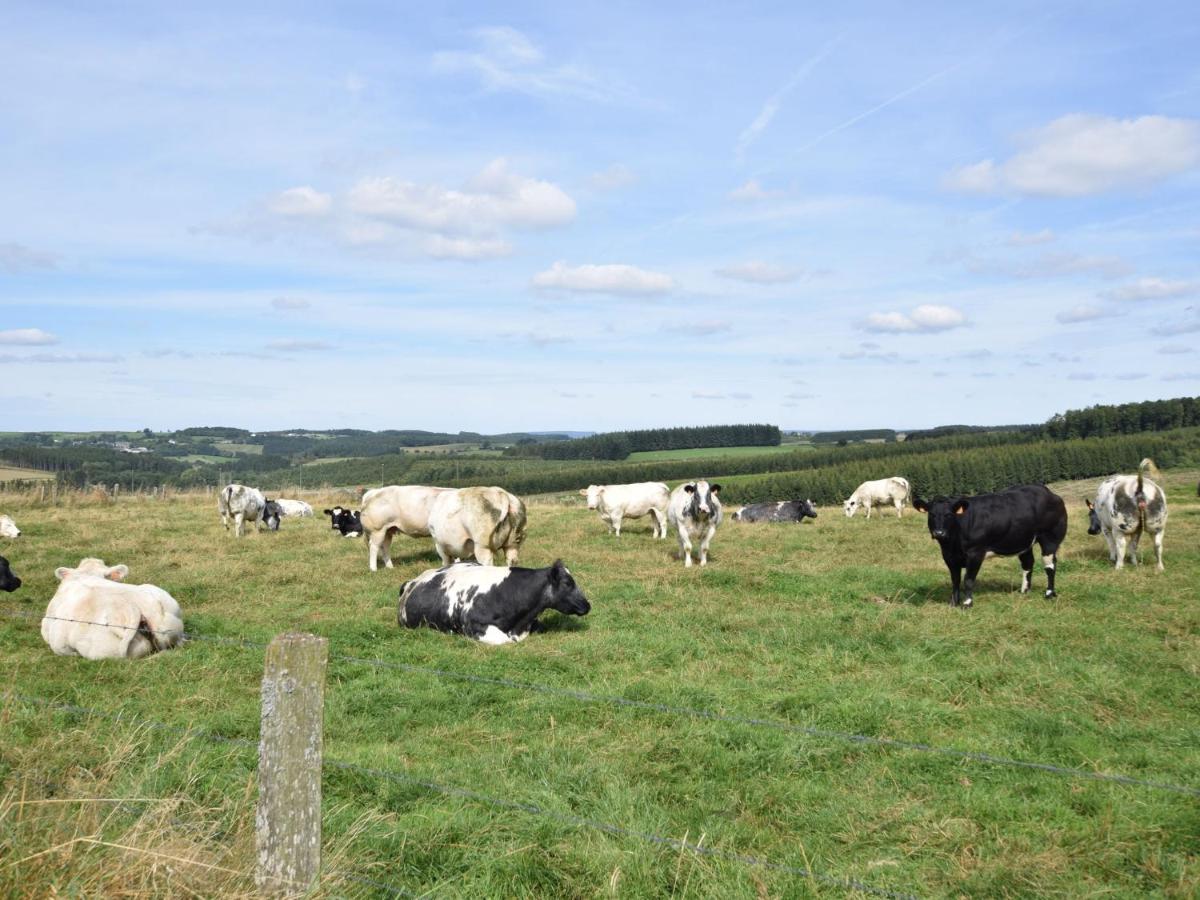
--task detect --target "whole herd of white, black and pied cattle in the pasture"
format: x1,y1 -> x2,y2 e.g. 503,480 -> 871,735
0,460 -> 1166,659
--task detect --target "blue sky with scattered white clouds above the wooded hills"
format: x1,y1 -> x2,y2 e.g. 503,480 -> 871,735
0,0 -> 1200,432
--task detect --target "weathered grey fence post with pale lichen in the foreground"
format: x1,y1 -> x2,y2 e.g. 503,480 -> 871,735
254,634 -> 329,896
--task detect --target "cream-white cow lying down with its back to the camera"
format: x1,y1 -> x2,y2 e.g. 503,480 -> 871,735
42,559 -> 184,659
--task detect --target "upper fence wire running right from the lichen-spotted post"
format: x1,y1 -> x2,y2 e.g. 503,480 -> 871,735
331,654 -> 1200,797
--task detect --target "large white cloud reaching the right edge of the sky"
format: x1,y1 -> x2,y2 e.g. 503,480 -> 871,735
944,113 -> 1200,197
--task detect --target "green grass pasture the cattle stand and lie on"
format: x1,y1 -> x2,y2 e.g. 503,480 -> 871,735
0,472 -> 1200,898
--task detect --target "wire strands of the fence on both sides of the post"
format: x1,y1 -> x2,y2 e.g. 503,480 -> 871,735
7,608 -> 1200,898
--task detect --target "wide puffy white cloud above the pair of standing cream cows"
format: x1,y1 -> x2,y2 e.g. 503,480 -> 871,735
347,158 -> 576,234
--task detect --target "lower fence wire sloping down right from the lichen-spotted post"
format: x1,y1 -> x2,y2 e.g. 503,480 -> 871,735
325,760 -> 914,899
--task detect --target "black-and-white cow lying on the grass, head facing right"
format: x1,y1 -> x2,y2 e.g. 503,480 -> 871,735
396,559 -> 592,644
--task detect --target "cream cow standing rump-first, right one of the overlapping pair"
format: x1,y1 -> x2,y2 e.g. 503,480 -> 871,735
430,487 -> 526,565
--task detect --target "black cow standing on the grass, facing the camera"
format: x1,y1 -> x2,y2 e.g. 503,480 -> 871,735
912,485 -> 1067,606
